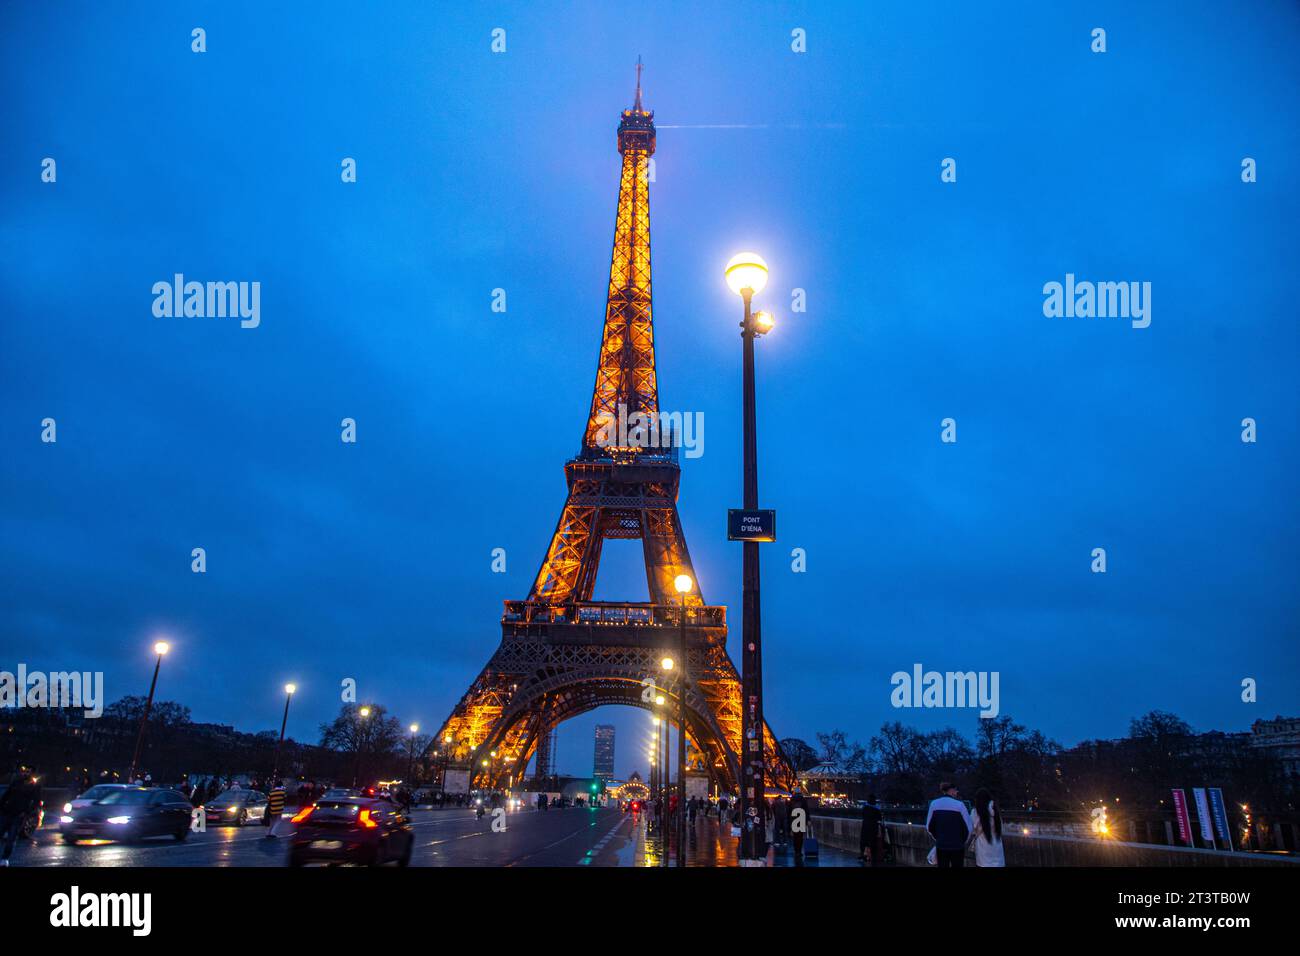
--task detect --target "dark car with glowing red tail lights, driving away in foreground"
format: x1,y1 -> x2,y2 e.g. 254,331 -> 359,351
289,797 -> 415,866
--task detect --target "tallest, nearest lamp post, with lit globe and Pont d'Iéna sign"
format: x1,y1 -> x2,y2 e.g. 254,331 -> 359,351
724,252 -> 772,856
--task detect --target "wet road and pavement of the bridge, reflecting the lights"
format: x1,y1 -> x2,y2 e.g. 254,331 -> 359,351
13,808 -> 857,868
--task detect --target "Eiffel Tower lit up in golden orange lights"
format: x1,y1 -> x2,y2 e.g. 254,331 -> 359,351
429,67 -> 793,793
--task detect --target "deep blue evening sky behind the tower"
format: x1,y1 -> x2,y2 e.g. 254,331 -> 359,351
0,0 -> 1300,775
